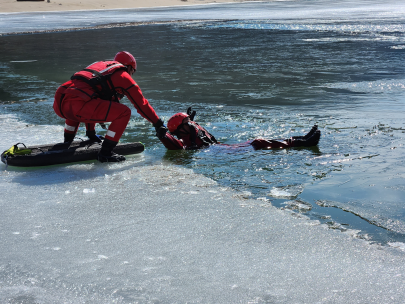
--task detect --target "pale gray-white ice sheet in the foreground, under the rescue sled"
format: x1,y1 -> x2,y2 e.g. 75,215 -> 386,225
0,115 -> 405,303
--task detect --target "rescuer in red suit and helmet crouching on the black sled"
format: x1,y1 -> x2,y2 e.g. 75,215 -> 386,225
53,52 -> 165,162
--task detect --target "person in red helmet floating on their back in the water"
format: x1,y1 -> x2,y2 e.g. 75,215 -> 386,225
156,108 -> 321,150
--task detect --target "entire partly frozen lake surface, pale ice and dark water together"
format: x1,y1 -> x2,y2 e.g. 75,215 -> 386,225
0,1 -> 405,304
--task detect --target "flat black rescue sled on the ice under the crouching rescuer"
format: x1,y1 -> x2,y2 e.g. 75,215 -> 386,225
1,140 -> 145,167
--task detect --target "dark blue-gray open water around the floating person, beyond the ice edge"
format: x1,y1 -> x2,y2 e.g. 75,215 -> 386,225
0,1 -> 405,303
